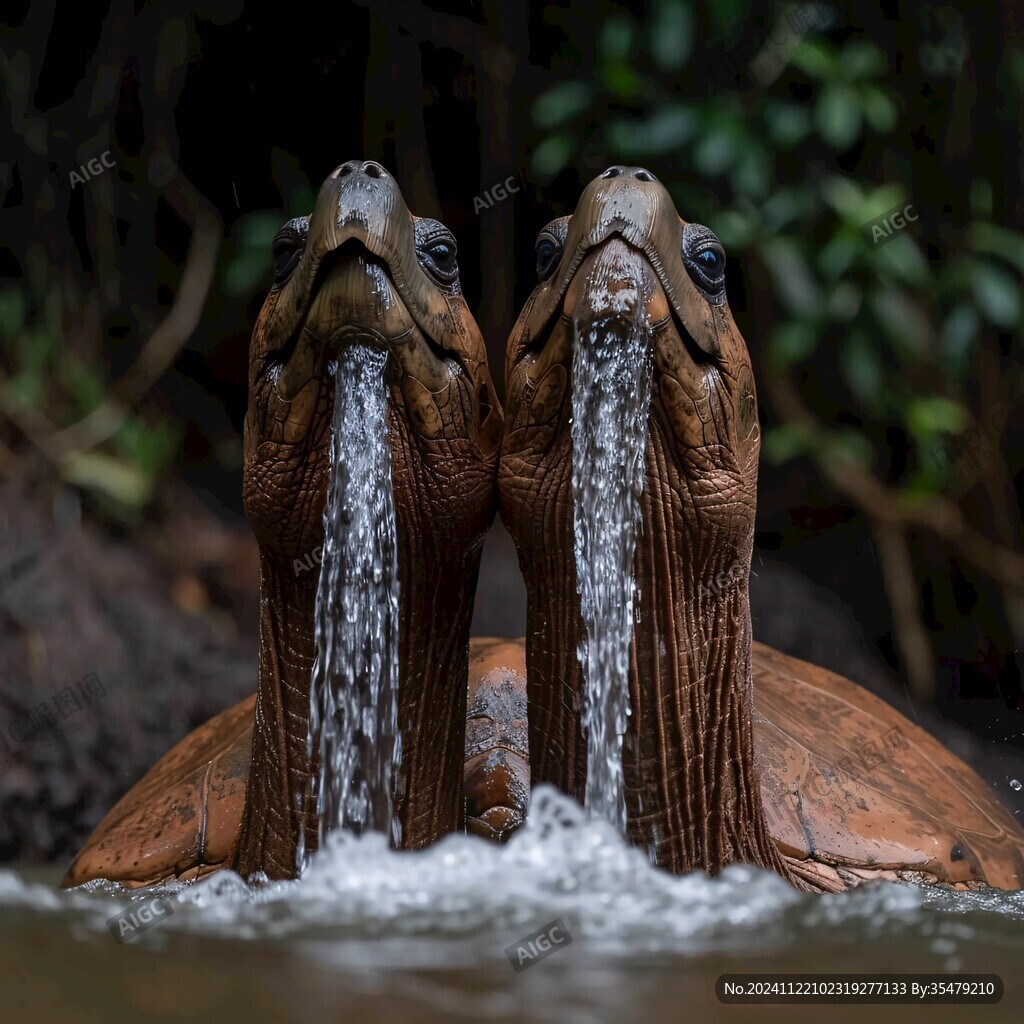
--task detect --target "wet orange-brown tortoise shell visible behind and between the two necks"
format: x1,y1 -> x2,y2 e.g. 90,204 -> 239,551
63,638 -> 1024,892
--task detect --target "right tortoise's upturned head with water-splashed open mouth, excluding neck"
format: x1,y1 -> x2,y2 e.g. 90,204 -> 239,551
506,167 -> 760,475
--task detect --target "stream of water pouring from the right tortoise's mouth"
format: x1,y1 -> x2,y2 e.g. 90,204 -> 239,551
571,292 -> 653,834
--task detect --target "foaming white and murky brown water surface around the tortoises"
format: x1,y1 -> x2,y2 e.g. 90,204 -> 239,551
0,790 -> 1024,1024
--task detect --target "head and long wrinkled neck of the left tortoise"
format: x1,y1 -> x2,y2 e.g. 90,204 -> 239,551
234,161 -> 502,879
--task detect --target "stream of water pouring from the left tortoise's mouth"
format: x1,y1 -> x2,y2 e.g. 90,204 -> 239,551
300,345 -> 401,863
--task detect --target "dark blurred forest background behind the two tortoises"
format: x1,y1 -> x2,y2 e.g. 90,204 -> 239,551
0,0 -> 1024,860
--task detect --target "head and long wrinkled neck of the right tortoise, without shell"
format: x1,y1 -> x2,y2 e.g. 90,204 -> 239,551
499,166 -> 778,870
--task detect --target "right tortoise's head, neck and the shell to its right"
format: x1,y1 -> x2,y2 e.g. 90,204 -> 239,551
491,165 -> 1024,890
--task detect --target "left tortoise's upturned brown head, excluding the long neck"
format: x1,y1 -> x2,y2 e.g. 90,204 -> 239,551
245,160 -> 501,558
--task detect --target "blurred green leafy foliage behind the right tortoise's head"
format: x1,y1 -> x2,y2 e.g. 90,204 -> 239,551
534,0 -> 1024,500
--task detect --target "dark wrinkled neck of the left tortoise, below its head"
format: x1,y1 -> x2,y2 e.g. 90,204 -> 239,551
238,323 -> 497,879
